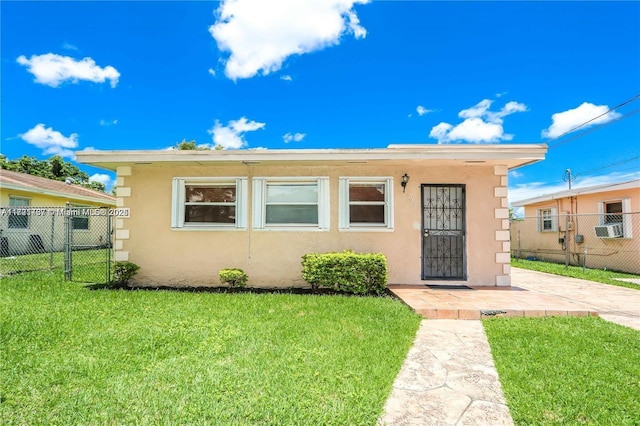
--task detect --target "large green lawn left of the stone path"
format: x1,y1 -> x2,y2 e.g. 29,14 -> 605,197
0,272 -> 420,425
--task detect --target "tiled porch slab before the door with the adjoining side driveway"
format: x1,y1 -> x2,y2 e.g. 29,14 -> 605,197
389,268 -> 640,322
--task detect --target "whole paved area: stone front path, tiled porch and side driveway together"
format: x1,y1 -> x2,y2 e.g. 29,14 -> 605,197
378,268 -> 640,426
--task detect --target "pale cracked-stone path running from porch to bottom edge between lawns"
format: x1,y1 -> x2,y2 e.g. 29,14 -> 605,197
378,320 -> 513,426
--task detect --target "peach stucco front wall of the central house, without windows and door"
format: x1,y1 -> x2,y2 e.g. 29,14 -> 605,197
115,162 -> 510,287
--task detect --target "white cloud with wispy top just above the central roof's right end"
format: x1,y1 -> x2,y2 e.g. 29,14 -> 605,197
429,99 -> 527,143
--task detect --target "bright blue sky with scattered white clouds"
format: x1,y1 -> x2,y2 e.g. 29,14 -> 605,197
0,0 -> 640,201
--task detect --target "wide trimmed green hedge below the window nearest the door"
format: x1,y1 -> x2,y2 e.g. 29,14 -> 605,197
302,250 -> 387,294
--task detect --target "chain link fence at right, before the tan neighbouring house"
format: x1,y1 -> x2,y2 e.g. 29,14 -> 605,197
511,213 -> 640,274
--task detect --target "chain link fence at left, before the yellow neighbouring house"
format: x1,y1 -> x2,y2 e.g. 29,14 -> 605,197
0,205 -> 113,283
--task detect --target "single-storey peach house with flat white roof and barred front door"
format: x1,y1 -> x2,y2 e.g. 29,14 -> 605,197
76,144 -> 547,287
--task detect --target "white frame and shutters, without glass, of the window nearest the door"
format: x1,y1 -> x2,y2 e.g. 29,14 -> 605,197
338,176 -> 393,232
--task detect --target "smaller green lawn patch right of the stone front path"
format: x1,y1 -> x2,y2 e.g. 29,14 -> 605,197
483,317 -> 640,426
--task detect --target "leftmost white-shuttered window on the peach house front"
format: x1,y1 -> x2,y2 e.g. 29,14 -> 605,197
171,178 -> 247,229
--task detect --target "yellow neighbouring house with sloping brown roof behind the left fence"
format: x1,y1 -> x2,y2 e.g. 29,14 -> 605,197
0,169 -> 116,257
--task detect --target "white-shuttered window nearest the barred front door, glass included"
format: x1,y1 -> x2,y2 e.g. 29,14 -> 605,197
340,177 -> 393,230
